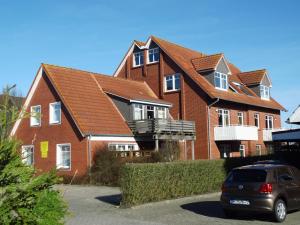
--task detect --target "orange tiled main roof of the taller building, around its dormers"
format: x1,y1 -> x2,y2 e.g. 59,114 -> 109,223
151,36 -> 285,110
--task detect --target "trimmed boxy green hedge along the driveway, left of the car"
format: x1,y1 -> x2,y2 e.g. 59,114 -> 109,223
120,160 -> 226,206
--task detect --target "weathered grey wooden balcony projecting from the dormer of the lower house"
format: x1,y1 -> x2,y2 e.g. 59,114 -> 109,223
127,119 -> 196,140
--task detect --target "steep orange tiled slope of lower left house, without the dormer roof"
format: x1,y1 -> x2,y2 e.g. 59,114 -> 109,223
42,64 -> 132,135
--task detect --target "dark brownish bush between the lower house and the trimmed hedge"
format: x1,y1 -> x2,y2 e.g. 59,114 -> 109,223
91,149 -> 162,186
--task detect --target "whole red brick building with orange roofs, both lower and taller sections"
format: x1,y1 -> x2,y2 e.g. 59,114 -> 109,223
12,37 -> 284,175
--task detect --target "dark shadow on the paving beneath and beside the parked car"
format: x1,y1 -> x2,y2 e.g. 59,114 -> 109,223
180,201 -> 272,222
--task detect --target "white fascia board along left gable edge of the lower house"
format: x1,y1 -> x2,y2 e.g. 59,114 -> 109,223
10,66 -> 43,136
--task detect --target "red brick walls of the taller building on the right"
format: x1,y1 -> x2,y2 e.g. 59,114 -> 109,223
118,48 -> 281,159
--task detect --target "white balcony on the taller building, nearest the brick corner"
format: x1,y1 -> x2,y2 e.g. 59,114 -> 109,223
214,125 -> 258,141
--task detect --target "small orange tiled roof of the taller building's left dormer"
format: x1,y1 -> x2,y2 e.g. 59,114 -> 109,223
192,53 -> 223,72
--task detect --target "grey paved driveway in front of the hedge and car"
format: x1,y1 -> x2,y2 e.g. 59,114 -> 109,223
59,185 -> 300,225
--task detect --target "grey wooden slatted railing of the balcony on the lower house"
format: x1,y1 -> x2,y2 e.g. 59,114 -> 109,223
127,119 -> 195,135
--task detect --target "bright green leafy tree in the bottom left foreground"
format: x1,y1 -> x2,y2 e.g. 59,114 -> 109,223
0,85 -> 67,225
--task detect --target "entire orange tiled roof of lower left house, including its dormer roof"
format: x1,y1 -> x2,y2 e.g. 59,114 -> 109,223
42,64 -> 169,136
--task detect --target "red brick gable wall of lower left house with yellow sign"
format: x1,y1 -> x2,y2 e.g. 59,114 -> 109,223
16,75 -> 87,176
